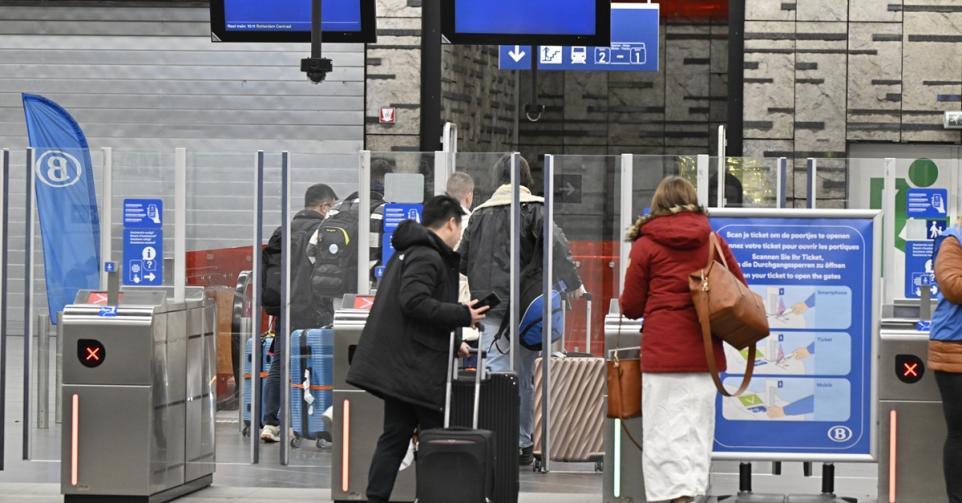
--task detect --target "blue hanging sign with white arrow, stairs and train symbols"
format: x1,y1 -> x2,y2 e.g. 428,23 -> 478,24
499,4 -> 659,72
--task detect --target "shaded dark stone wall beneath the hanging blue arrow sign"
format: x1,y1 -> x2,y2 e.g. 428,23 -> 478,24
520,23 -> 728,156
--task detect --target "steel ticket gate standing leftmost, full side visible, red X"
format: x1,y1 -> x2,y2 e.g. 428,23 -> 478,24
61,287 -> 216,503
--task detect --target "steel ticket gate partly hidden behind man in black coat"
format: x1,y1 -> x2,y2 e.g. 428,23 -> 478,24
331,295 -> 417,503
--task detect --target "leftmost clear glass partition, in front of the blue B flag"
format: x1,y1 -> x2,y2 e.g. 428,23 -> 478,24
22,149 -> 103,461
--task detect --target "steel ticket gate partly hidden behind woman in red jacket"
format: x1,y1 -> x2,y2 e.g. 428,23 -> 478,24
604,299 -> 646,503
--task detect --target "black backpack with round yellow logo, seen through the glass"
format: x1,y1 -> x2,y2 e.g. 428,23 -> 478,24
308,197 -> 384,298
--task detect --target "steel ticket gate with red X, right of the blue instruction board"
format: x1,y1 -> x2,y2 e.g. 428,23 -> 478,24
878,300 -> 947,503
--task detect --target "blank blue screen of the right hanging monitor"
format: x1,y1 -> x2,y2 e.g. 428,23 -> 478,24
454,0 -> 596,36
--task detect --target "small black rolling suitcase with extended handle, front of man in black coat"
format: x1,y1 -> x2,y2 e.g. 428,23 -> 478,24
417,334 -> 497,503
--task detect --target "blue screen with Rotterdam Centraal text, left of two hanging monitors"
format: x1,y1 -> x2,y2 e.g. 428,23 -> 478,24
224,0 -> 362,32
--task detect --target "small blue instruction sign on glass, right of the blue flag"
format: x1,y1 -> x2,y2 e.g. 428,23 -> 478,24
122,199 -> 164,286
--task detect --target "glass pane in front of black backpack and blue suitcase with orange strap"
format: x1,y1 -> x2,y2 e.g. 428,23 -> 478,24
284,152 -> 362,469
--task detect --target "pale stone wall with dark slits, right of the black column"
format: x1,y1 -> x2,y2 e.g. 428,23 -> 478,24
744,0 -> 962,206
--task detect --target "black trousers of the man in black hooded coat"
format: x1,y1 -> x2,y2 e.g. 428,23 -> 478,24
367,399 -> 444,503
